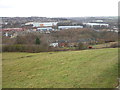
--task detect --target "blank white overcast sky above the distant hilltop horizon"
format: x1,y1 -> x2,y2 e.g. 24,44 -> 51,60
0,0 -> 119,17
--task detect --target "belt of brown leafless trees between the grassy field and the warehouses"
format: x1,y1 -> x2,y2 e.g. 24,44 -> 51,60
2,29 -> 118,52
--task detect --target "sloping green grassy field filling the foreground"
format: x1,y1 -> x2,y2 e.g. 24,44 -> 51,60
2,48 -> 118,88
